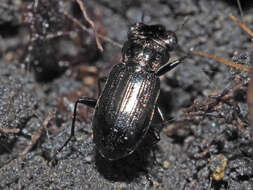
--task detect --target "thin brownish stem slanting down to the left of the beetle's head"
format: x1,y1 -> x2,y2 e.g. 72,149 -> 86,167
63,12 -> 122,48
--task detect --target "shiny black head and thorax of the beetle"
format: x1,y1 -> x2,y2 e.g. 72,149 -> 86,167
122,23 -> 177,72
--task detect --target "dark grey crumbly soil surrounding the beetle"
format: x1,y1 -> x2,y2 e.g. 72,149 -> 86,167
0,0 -> 253,190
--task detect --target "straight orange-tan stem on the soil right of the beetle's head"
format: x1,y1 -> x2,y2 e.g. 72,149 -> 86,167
192,51 -> 251,72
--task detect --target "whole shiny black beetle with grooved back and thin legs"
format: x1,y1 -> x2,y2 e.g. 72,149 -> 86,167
58,23 -> 184,160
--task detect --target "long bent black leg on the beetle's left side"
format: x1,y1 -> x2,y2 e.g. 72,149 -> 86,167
56,97 -> 97,154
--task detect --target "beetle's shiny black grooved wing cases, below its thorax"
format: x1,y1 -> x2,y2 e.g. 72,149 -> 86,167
92,63 -> 160,160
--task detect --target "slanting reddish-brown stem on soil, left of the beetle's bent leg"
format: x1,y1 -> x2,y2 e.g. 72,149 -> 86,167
20,112 -> 53,156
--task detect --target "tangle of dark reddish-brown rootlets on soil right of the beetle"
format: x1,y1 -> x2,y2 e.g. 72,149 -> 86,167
172,82 -> 248,139
